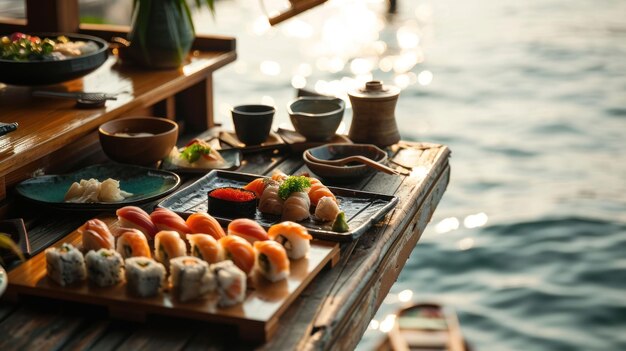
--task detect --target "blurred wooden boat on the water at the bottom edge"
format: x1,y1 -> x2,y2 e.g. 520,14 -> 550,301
377,303 -> 469,351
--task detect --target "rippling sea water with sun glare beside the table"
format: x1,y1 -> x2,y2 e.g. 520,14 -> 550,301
197,0 -> 626,350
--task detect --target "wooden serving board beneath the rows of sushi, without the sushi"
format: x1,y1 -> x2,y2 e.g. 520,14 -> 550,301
6,218 -> 339,342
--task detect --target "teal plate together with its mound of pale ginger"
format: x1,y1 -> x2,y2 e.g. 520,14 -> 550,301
15,164 -> 180,211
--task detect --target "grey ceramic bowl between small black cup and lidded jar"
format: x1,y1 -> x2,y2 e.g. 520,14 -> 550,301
287,96 -> 346,141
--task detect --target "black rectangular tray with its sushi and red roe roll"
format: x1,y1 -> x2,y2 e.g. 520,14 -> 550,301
157,170 -> 398,241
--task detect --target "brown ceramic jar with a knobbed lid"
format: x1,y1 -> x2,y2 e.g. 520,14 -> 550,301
348,81 -> 400,147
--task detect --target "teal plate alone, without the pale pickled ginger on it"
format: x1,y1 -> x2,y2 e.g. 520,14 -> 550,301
15,164 -> 180,210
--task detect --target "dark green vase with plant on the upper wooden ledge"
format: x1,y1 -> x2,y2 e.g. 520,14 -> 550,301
128,0 -> 215,68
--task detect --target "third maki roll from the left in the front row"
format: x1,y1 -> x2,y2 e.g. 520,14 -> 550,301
125,257 -> 165,297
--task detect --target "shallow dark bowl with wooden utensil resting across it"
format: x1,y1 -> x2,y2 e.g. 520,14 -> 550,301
302,144 -> 387,180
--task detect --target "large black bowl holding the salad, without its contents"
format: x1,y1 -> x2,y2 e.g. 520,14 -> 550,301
0,33 -> 109,85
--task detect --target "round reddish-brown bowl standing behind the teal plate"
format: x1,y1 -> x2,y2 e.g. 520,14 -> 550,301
98,117 -> 178,165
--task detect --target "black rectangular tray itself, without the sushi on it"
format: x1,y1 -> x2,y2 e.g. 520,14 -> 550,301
157,170 -> 398,241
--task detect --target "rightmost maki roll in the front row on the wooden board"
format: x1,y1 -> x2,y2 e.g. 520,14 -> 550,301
211,261 -> 246,307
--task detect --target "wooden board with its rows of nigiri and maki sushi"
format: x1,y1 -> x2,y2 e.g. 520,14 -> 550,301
8,210 -> 339,340
